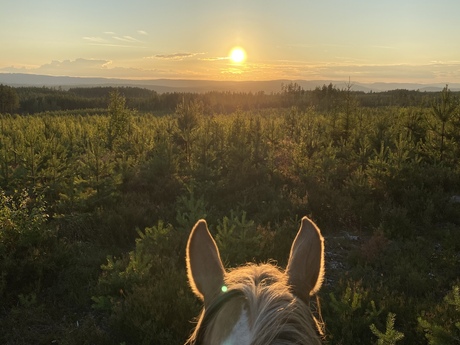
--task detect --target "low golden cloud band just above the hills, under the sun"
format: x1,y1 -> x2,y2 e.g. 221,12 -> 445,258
0,57 -> 460,84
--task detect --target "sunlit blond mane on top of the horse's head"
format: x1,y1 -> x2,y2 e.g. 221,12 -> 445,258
186,263 -> 322,345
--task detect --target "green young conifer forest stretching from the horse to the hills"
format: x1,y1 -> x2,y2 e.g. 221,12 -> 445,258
0,84 -> 460,345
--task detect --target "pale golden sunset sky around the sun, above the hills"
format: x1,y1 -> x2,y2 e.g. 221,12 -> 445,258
0,0 -> 460,84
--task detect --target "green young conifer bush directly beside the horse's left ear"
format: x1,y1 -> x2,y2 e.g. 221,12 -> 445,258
93,221 -> 198,344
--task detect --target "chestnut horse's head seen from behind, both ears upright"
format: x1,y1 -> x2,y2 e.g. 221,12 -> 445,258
185,217 -> 324,345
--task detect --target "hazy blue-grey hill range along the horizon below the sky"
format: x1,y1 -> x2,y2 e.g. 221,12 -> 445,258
0,73 -> 460,93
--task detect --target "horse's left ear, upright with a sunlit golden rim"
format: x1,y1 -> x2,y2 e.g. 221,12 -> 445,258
186,219 -> 225,305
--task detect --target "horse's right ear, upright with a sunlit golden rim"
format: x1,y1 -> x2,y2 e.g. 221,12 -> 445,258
286,217 -> 324,301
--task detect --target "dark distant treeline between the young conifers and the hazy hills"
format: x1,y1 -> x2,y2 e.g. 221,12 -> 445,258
0,83 -> 452,114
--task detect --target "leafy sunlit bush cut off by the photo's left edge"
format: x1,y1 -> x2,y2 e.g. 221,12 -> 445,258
0,191 -> 62,306
